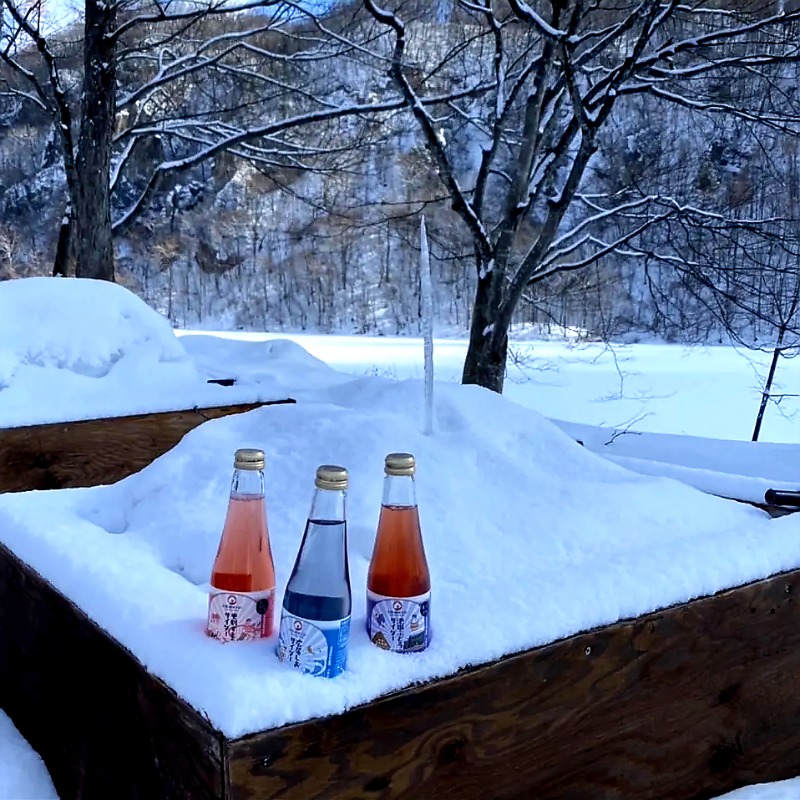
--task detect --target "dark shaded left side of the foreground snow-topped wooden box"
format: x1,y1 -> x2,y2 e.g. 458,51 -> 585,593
0,545 -> 224,800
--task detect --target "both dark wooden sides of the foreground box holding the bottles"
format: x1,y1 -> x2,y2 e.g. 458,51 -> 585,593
0,546 -> 800,800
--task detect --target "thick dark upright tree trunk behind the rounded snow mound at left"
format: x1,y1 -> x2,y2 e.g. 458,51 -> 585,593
72,0 -> 117,281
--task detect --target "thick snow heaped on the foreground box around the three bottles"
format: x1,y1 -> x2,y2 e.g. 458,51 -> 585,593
0,368 -> 800,736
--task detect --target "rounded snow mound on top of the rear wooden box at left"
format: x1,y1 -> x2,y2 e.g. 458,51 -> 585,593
0,278 -> 278,427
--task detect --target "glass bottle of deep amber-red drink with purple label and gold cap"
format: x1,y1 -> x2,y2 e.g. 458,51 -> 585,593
367,453 -> 431,653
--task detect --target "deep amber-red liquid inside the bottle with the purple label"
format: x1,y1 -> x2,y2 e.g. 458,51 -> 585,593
367,506 -> 431,597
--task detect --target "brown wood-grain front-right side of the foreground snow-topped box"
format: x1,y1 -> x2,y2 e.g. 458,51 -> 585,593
227,570 -> 800,800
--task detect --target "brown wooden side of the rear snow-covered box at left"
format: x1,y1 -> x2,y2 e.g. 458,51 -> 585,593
0,398 -> 294,492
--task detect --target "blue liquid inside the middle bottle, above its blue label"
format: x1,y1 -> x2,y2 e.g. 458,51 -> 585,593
283,520 -> 352,622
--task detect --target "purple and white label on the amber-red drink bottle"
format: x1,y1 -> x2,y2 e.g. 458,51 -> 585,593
367,590 -> 431,653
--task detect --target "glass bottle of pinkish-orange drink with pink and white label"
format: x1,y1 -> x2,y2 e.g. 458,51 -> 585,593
206,448 -> 275,642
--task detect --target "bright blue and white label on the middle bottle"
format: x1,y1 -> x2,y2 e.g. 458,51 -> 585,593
278,609 -> 350,678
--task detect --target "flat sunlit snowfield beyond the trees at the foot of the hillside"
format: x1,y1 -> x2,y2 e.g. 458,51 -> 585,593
176,330 -> 800,444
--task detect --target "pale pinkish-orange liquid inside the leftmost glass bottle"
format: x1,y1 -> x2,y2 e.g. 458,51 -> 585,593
211,495 -> 275,592
